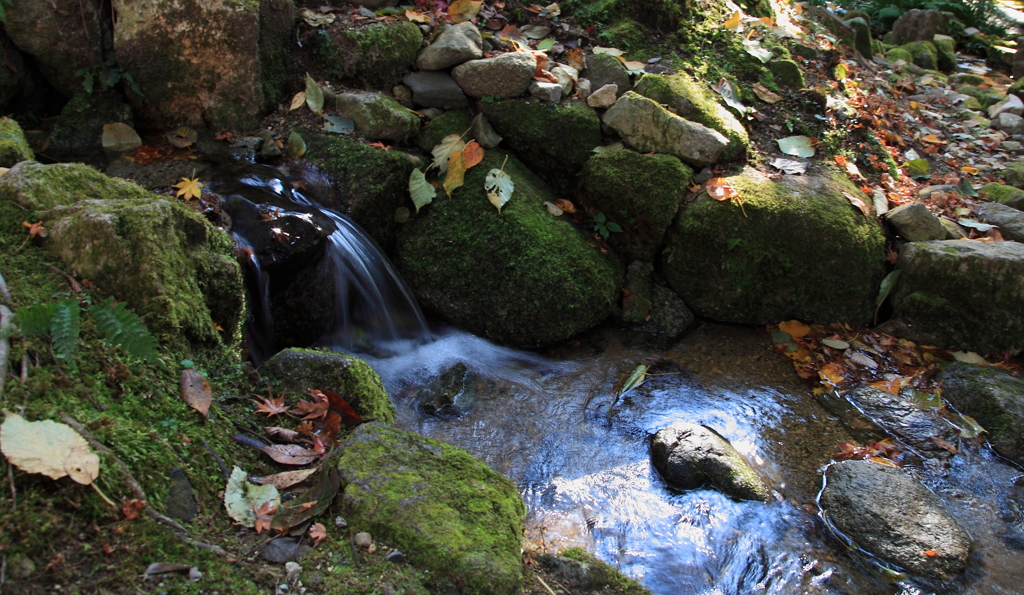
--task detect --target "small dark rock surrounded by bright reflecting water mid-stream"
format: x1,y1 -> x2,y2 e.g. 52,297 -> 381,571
650,422 -> 768,502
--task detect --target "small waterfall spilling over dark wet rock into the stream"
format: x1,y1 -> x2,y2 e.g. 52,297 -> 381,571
209,165 -> 430,365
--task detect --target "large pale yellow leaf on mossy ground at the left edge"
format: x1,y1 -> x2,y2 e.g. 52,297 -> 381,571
0,410 -> 99,485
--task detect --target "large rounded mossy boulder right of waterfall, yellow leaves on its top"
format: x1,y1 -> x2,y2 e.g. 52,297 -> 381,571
396,150 -> 623,345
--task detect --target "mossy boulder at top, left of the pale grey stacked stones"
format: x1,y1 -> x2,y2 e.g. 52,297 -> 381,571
312,19 -> 423,87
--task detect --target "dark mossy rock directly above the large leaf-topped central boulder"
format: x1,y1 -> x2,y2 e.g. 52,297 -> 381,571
480,99 -> 601,190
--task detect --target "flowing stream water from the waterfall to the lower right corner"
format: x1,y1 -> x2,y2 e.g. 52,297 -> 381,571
222,163 -> 1024,595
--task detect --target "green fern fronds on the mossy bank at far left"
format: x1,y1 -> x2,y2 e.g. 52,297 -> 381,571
14,297 -> 158,364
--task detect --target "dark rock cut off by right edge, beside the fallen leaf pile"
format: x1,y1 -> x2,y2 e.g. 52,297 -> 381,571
939,362 -> 1024,465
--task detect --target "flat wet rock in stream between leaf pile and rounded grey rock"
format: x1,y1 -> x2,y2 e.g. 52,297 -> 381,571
847,385 -> 957,459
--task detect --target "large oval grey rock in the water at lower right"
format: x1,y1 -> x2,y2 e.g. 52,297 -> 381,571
819,461 -> 971,580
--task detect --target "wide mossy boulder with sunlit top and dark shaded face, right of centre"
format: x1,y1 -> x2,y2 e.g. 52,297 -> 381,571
662,168 -> 885,325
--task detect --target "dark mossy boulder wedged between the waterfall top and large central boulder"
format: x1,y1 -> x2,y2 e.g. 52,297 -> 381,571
303,128 -> 415,254
